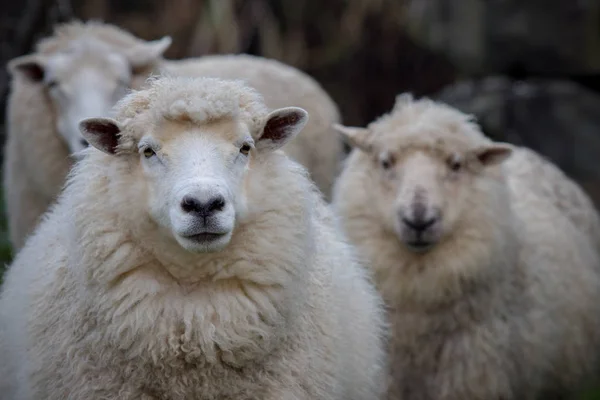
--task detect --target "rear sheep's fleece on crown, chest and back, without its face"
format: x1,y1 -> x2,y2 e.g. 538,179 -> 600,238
4,21 -> 343,251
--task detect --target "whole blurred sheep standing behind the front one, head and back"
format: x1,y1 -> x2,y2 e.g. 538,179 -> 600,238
4,21 -> 343,250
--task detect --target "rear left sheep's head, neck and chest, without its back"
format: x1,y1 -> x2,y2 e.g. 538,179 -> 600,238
3,22 -> 171,252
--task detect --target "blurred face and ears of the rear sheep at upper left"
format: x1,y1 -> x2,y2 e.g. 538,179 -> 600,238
9,38 -> 170,154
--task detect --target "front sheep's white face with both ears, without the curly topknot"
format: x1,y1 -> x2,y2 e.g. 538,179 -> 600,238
81,99 -> 307,253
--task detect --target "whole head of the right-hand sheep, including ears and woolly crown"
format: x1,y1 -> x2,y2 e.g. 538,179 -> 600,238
336,97 -> 512,252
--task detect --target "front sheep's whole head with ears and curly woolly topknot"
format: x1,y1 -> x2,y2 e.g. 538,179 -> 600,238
80,77 -> 308,252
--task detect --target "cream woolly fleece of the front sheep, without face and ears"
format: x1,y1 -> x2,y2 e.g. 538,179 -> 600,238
0,78 -> 386,400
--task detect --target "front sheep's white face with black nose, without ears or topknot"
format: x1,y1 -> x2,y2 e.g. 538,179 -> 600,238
138,120 -> 254,252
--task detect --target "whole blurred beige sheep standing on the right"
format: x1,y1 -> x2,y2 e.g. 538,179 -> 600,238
333,94 -> 600,400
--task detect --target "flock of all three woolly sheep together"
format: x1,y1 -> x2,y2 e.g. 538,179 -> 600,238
0,21 -> 600,400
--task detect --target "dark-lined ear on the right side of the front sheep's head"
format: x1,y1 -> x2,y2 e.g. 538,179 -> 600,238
256,107 -> 308,151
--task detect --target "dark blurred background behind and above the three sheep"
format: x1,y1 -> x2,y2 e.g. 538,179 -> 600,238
0,0 -> 600,399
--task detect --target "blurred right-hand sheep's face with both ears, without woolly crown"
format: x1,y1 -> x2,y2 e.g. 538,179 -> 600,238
338,126 -> 511,252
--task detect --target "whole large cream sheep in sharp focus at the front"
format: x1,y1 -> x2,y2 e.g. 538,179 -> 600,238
0,76 -> 387,400
